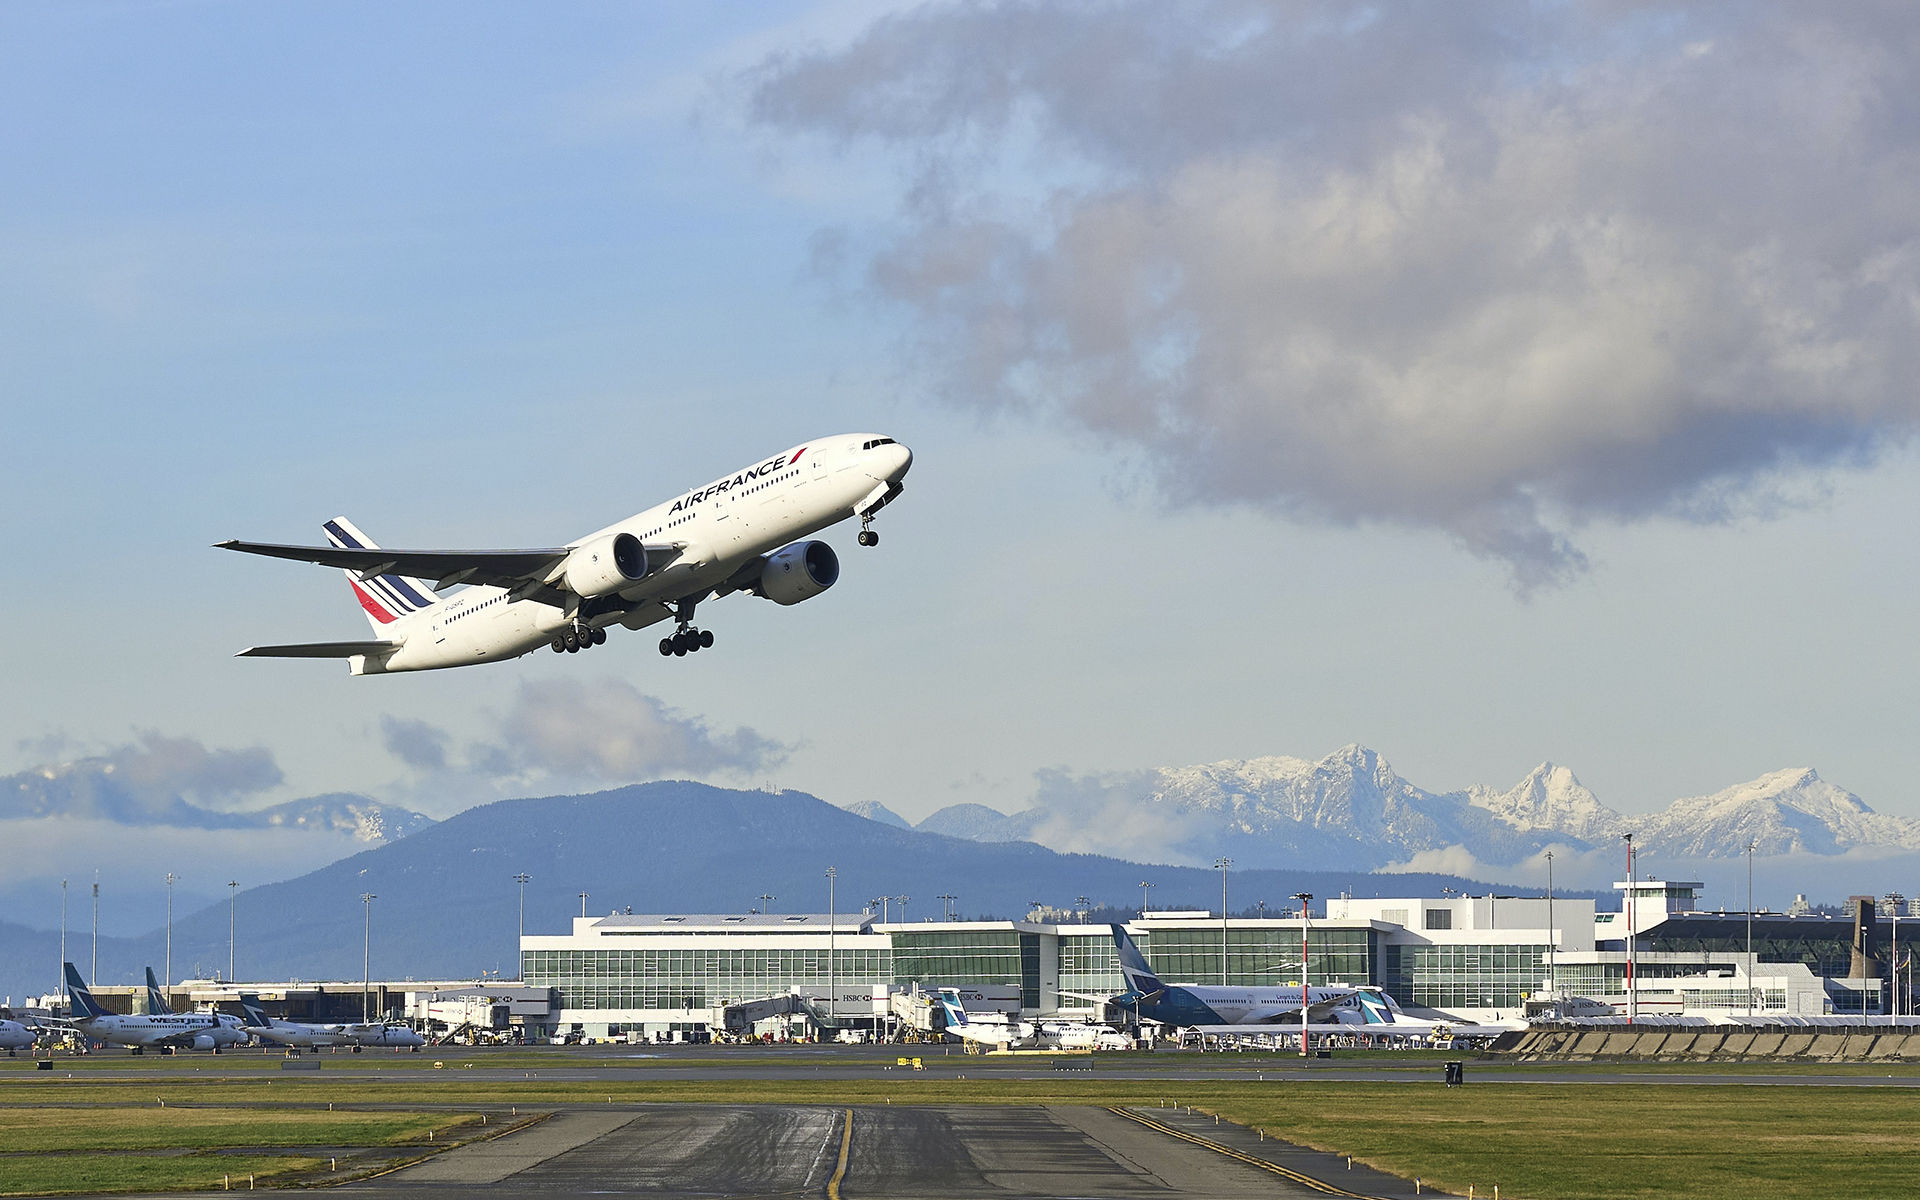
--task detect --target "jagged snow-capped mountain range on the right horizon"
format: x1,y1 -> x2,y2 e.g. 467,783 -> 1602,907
868,745 -> 1920,870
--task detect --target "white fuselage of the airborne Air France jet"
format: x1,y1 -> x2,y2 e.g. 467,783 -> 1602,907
351,434 -> 912,674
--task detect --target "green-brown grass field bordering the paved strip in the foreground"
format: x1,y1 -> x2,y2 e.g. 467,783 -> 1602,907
0,1058 -> 1920,1200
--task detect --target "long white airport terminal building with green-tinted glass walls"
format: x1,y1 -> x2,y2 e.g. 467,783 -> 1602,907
520,879 -> 1920,1039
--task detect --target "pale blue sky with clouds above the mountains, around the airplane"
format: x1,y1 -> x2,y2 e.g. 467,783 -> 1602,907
0,0 -> 1920,895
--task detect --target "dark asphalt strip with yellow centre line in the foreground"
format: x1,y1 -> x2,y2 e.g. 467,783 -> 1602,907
340,1104 -> 1413,1200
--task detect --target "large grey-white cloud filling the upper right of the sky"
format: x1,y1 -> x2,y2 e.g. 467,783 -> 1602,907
747,2 -> 1920,589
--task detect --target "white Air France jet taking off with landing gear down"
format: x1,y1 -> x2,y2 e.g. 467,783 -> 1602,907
217,434 -> 914,676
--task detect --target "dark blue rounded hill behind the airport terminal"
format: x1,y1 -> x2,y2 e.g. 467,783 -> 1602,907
0,781 -> 1512,987
